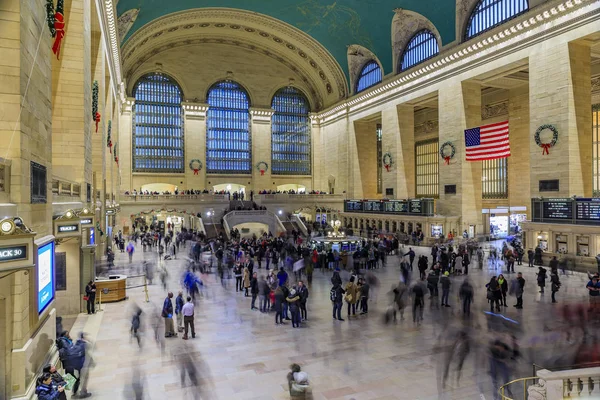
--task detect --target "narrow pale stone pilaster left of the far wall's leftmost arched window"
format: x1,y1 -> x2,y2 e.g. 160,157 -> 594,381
119,97 -> 134,192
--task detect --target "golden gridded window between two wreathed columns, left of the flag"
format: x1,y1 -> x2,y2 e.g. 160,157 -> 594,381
415,139 -> 439,198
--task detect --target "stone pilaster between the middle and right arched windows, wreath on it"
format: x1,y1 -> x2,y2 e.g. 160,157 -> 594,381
251,107 -> 274,195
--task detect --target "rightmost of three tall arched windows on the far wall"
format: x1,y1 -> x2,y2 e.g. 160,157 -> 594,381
271,86 -> 311,175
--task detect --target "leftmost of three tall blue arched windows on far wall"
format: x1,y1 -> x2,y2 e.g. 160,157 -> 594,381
132,73 -> 184,172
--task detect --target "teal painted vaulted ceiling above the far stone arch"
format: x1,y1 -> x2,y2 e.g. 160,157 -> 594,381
117,0 -> 456,79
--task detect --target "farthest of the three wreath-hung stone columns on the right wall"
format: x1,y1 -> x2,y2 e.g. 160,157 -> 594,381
381,105 -> 415,199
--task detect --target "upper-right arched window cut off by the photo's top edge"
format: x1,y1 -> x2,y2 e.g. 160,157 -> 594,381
465,0 -> 529,40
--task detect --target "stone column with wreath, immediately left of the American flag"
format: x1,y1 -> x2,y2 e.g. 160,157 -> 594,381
437,82 -> 483,234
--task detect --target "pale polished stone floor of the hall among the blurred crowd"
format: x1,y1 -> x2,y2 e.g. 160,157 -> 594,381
76,242 -> 587,400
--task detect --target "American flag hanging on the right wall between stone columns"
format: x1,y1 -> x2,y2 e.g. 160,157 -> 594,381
465,121 -> 510,161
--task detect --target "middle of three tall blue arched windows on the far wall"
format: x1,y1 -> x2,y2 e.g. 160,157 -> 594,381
206,81 -> 252,174
